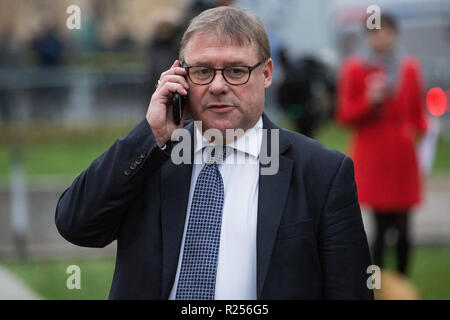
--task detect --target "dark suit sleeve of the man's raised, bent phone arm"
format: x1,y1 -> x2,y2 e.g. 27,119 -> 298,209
55,120 -> 170,247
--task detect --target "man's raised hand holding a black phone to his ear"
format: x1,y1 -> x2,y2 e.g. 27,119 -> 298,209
146,60 -> 189,147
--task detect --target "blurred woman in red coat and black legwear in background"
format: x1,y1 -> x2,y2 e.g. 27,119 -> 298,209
336,14 -> 426,274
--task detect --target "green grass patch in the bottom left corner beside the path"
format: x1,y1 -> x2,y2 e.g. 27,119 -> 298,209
4,259 -> 114,300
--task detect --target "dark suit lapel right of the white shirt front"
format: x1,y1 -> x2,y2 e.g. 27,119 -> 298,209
256,114 -> 293,299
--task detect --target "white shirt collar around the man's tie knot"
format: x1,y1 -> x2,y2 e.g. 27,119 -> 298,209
194,117 -> 263,159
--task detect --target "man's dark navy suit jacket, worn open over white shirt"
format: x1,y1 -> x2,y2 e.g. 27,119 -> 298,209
55,115 -> 373,299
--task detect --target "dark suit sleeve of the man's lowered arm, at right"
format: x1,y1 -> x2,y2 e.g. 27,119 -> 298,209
319,156 -> 373,299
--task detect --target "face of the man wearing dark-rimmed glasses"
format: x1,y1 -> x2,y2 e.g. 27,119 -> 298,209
184,34 -> 273,134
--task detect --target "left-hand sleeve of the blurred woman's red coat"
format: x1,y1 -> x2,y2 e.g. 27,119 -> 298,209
335,59 -> 374,126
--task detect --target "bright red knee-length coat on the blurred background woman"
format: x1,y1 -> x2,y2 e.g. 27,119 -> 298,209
336,58 -> 426,211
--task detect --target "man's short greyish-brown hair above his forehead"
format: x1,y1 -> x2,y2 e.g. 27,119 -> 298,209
179,7 -> 270,62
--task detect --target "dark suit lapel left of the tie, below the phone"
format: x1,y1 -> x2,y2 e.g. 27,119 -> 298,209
161,123 -> 193,300
